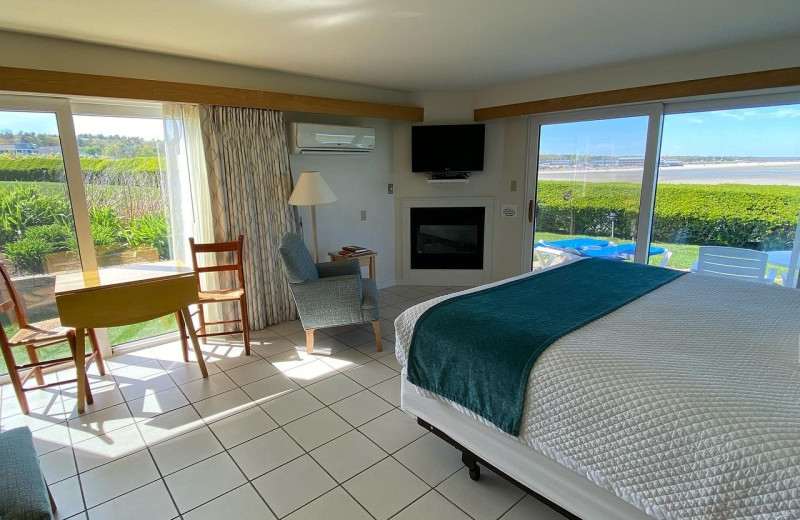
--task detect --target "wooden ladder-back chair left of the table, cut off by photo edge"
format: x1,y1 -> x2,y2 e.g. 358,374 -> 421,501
0,263 -> 106,414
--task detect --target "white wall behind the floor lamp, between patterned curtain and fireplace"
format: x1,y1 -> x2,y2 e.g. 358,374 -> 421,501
285,113 -> 396,288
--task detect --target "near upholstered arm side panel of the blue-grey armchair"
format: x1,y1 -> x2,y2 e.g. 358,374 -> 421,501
290,274 -> 364,329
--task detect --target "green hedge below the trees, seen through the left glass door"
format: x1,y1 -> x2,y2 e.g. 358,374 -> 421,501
0,155 -> 165,186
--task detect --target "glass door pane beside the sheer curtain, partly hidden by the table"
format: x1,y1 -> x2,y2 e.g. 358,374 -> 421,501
73,113 -> 179,346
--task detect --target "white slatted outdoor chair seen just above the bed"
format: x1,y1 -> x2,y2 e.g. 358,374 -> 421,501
692,246 -> 777,284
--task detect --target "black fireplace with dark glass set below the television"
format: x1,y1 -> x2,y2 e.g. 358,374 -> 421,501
411,207 -> 486,269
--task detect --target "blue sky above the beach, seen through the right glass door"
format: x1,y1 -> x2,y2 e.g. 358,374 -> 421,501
540,105 -> 800,157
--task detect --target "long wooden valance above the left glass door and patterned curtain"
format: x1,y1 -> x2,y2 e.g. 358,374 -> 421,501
0,67 -> 424,122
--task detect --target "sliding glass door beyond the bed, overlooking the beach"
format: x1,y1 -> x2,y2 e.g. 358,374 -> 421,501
523,94 -> 800,287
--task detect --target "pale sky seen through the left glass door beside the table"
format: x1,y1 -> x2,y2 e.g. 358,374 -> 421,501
0,111 -> 164,140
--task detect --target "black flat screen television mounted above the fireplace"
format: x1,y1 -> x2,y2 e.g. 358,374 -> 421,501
411,124 -> 486,173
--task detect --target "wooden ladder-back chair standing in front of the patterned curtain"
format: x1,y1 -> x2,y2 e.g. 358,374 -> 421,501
176,235 -> 250,361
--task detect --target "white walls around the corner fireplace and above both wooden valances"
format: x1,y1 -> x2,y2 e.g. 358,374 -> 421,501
7,31 -> 800,285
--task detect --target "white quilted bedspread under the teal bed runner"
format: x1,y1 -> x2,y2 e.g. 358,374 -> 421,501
395,264 -> 800,519
